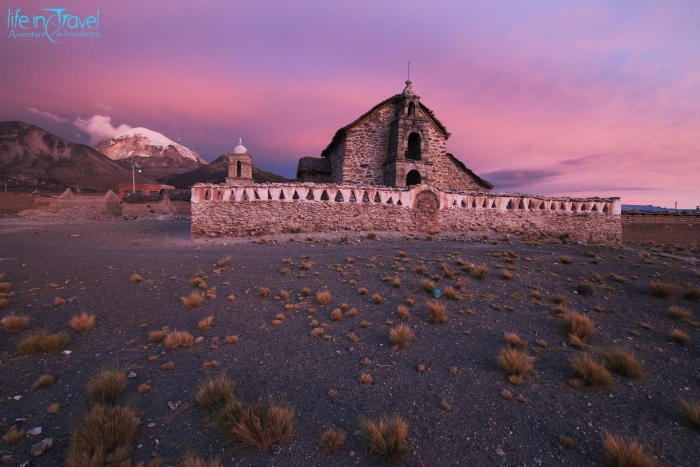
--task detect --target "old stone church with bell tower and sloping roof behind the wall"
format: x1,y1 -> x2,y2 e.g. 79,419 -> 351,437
297,80 -> 493,192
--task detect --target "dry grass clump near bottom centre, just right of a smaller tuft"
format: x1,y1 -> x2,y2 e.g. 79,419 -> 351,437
360,415 -> 411,462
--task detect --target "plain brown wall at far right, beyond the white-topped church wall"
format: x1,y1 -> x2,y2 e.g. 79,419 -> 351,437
622,212 -> 700,245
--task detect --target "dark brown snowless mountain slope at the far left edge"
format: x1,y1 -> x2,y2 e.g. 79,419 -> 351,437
0,122 -> 153,193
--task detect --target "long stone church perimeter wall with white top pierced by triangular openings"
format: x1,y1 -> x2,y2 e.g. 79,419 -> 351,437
191,183 -> 622,243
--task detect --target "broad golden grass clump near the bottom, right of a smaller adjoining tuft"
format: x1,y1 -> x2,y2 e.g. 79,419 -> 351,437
216,398 -> 294,449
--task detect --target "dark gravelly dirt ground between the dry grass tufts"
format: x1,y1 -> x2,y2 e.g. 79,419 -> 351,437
0,218 -> 700,466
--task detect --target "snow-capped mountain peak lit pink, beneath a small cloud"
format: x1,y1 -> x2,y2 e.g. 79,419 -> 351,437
95,128 -> 207,178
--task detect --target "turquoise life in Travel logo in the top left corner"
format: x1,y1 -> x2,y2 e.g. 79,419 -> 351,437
7,8 -> 100,44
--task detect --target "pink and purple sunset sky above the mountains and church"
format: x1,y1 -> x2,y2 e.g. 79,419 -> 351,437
0,0 -> 700,207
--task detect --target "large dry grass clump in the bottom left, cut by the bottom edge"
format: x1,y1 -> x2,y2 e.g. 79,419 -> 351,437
66,404 -> 136,467
